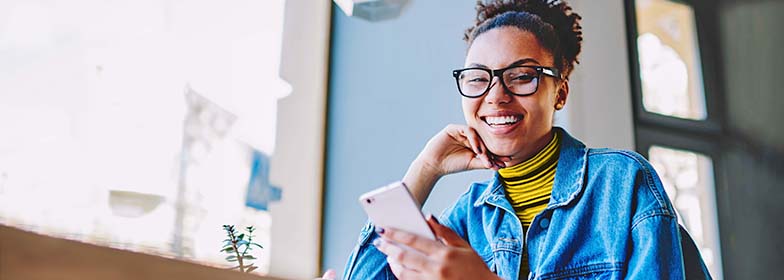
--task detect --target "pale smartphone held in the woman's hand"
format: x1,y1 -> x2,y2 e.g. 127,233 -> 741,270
359,182 -> 436,240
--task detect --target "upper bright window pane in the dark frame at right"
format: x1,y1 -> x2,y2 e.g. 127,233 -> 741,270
635,0 -> 708,120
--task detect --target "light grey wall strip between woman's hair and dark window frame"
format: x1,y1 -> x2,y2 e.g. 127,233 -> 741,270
564,0 -> 634,150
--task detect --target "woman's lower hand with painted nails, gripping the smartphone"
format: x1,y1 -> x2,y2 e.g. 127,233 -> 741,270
373,216 -> 498,279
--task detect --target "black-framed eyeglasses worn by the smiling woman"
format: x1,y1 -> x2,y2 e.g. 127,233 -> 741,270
452,66 -> 561,98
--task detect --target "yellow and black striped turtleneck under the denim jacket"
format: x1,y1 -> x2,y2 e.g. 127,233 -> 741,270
498,132 -> 561,230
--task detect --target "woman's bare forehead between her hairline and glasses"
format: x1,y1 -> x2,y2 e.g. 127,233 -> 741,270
465,26 -> 553,69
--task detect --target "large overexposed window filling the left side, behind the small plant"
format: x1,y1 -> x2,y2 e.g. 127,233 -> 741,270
0,0 -> 290,278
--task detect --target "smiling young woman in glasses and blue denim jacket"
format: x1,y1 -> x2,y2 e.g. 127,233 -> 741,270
344,0 -> 709,279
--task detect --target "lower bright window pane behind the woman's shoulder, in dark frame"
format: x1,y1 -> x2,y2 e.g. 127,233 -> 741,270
648,146 -> 722,279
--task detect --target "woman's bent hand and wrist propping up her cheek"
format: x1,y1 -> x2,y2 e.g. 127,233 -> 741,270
403,124 -> 511,206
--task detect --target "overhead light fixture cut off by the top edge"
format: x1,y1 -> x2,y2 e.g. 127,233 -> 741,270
334,0 -> 408,21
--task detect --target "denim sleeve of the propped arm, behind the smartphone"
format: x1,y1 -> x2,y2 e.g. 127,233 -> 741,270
343,221 -> 396,279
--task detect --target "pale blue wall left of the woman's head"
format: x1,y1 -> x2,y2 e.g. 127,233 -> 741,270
322,0 -> 490,275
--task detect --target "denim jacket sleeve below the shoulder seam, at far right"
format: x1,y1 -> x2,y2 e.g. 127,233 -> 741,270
625,213 -> 685,279
